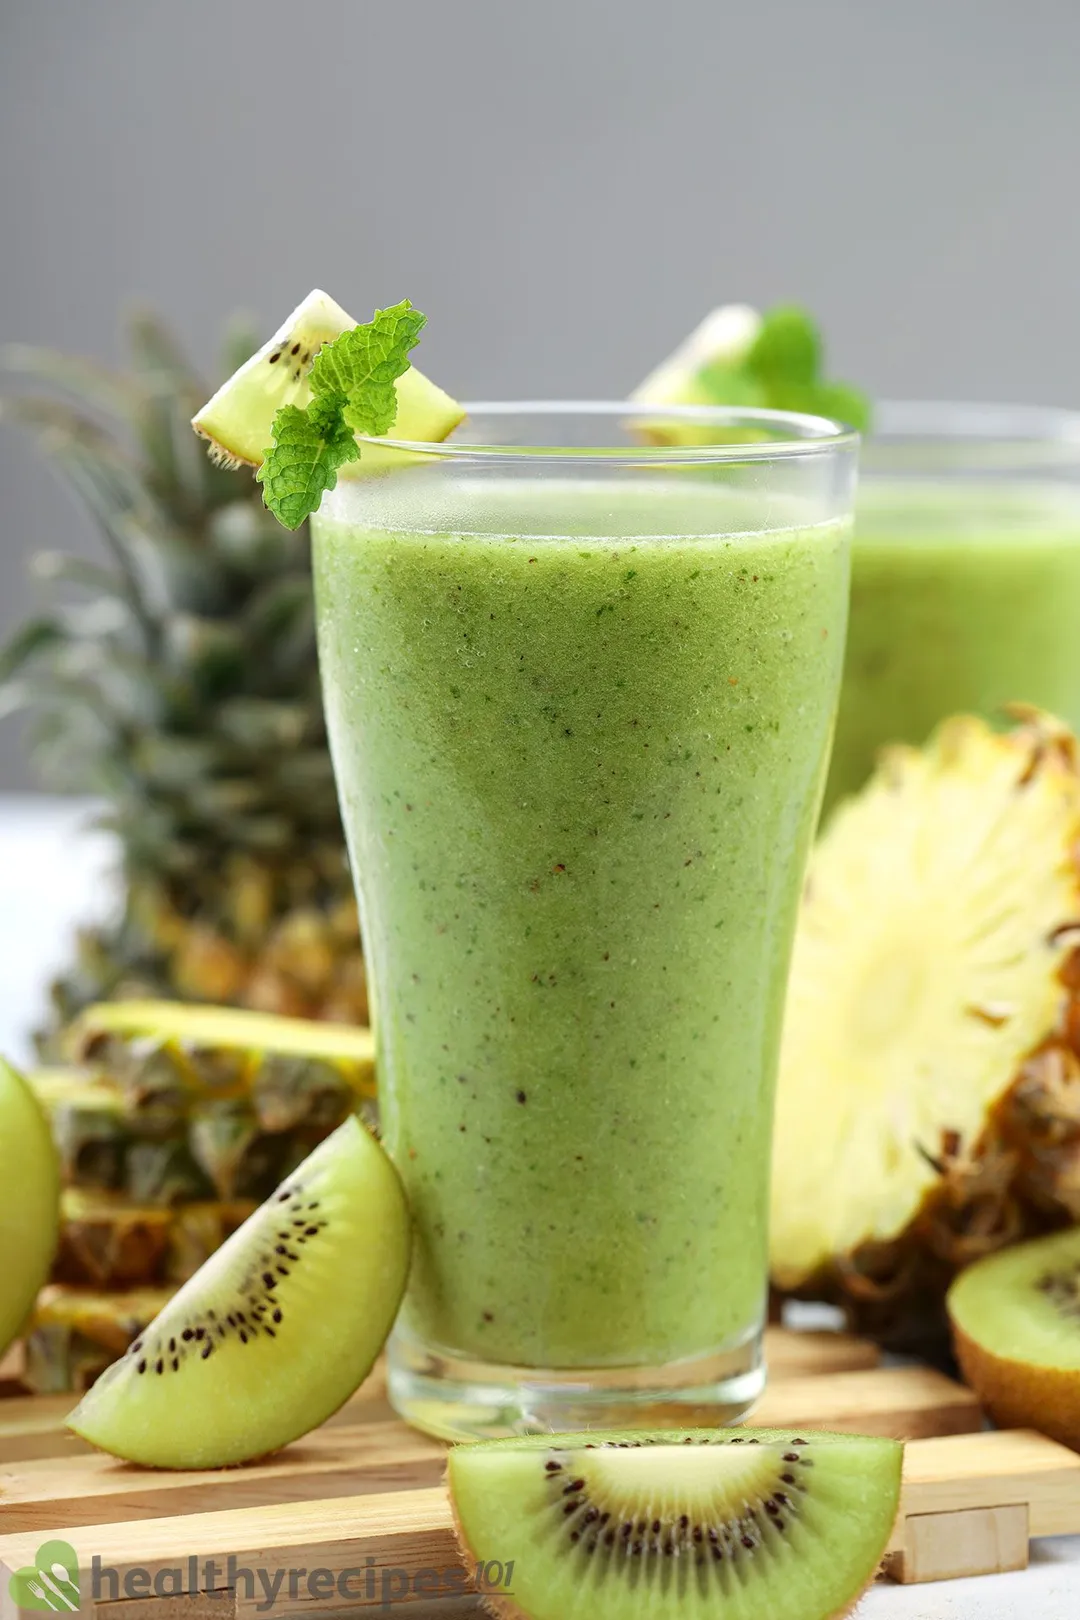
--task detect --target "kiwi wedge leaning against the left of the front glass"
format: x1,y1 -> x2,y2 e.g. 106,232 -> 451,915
68,1118 -> 411,1468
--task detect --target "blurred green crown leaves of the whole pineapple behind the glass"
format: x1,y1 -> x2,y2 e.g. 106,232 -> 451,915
0,314 -> 340,873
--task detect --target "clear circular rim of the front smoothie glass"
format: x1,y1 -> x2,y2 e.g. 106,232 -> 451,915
358,400 -> 860,467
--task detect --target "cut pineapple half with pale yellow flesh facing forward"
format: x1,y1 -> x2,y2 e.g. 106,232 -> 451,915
771,708 -> 1080,1343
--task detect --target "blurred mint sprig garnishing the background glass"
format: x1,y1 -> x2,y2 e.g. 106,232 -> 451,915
696,305 -> 871,431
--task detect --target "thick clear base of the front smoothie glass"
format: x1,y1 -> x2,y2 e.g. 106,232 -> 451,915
389,1330 -> 766,1440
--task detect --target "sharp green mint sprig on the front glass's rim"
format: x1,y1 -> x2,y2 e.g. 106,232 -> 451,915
256,298 -> 426,528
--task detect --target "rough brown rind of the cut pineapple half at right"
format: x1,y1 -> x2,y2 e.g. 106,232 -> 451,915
777,705 -> 1080,1362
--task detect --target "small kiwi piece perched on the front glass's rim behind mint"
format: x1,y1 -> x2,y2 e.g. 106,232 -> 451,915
191,288 -> 465,478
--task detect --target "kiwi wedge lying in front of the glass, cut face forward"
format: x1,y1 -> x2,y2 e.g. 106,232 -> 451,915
449,1429 -> 902,1620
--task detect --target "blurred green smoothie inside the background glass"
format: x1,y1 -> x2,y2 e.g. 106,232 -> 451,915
826,480 -> 1080,807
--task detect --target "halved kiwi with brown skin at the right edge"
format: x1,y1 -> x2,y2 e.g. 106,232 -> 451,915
947,1226 -> 1080,1450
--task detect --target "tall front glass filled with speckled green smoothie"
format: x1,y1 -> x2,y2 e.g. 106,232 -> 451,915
307,405 -> 857,1437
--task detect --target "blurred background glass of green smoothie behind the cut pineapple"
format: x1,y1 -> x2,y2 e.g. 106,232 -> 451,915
826,403 -> 1080,808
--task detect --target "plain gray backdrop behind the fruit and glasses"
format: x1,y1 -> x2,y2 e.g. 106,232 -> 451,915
0,0 -> 1080,789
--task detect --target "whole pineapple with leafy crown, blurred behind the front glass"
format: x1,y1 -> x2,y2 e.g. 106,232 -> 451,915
0,314 -> 368,1048
